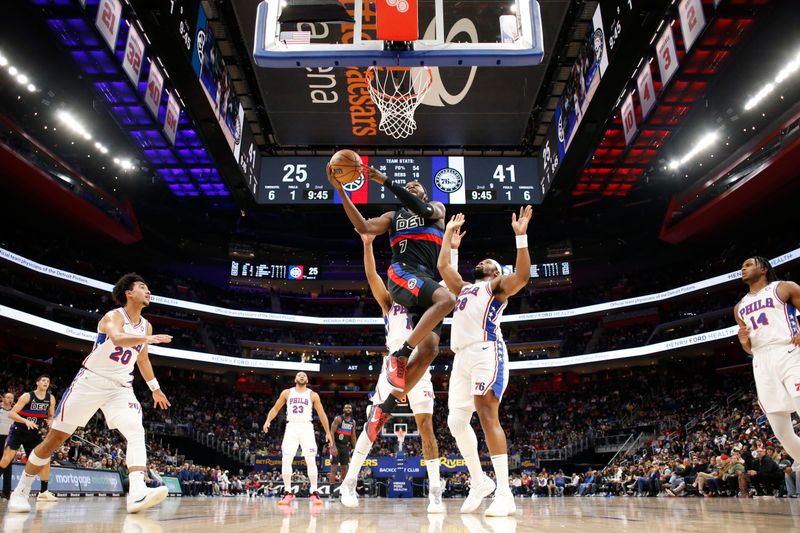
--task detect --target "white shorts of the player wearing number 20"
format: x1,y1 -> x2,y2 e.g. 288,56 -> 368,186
52,368 -> 142,435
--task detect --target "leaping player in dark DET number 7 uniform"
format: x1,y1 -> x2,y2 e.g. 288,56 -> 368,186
328,167 -> 456,441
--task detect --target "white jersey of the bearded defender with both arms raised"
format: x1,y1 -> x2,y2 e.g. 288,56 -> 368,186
450,281 -> 506,352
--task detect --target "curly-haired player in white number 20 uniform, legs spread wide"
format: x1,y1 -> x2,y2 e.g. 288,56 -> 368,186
8,274 -> 172,513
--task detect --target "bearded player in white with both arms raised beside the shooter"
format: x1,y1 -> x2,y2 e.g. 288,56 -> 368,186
438,206 -> 533,516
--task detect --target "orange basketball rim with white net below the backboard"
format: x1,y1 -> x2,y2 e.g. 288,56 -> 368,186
367,66 -> 433,139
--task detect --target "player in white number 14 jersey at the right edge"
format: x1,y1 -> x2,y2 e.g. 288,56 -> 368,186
733,256 -> 800,461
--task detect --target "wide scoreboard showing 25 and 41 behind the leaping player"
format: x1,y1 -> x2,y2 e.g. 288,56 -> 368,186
256,156 -> 542,205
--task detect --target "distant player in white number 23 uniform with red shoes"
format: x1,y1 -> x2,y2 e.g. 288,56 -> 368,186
264,372 -> 333,505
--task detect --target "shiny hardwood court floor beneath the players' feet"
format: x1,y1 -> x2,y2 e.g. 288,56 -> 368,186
0,497 -> 800,533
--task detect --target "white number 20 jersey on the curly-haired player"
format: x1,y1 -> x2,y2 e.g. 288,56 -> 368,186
83,307 -> 147,385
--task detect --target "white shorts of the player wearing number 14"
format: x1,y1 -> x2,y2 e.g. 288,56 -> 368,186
753,344 -> 800,413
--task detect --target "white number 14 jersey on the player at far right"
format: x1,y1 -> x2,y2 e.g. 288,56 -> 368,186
737,281 -> 798,355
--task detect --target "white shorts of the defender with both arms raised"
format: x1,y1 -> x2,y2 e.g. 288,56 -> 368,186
447,341 -> 508,409
